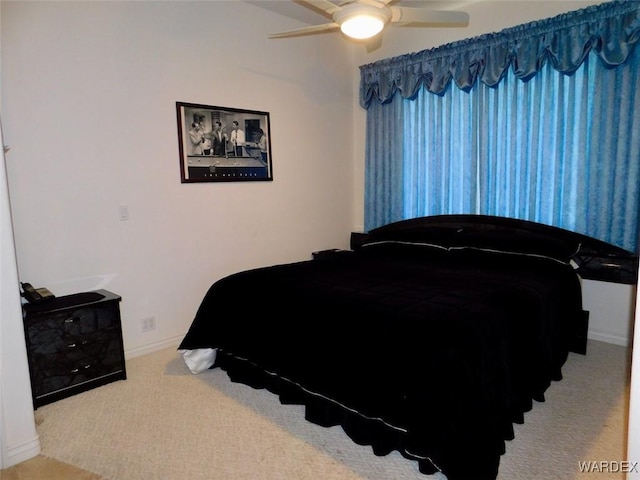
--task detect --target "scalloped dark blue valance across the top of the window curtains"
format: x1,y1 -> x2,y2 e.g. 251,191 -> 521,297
360,0 -> 640,108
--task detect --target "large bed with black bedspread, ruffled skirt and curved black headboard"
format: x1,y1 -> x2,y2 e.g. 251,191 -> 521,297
178,215 -> 637,480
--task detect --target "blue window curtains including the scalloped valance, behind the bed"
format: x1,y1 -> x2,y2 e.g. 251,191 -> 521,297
360,1 -> 640,251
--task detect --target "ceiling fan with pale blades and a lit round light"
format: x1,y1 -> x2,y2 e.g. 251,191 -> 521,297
269,0 -> 469,40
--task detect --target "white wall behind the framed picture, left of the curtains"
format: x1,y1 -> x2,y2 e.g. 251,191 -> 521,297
2,1 -> 354,355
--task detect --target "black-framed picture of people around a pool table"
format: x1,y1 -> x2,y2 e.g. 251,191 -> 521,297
176,102 -> 273,183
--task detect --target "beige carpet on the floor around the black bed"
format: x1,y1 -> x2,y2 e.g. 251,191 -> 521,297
36,341 -> 630,480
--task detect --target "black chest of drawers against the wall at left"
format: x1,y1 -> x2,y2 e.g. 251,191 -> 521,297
23,290 -> 127,408
